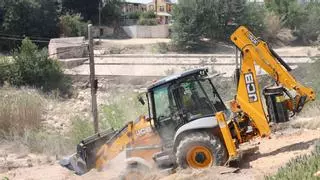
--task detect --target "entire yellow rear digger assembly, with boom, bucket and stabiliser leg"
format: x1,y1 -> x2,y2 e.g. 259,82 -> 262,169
216,26 -> 316,159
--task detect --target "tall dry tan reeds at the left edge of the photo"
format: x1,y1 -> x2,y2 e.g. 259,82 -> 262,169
0,88 -> 44,136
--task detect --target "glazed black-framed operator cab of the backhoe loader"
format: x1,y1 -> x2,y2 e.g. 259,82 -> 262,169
148,68 -> 227,141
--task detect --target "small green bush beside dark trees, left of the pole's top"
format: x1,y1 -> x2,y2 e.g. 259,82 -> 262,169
60,13 -> 88,37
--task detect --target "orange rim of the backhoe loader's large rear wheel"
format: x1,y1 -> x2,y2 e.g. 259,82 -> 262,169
186,146 -> 214,169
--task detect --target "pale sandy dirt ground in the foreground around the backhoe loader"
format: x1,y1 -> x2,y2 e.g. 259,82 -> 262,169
0,128 -> 320,180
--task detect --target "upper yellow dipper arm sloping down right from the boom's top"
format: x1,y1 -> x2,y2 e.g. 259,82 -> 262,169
231,26 -> 315,102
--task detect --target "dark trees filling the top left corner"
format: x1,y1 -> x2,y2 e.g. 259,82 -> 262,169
0,0 -> 59,48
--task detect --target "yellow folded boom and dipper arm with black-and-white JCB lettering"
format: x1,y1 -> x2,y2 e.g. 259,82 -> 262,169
231,26 -> 315,136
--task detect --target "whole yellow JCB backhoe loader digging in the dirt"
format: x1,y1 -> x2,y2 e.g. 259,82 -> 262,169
60,26 -> 316,179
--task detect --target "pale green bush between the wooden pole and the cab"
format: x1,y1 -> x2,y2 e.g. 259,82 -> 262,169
102,93 -> 147,129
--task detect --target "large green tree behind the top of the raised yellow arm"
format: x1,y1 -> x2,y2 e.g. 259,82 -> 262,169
172,0 -> 265,49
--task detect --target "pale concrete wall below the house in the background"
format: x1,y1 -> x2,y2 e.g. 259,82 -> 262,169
123,25 -> 169,38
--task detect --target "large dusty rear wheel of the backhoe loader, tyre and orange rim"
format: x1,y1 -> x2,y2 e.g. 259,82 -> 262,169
176,132 -> 226,169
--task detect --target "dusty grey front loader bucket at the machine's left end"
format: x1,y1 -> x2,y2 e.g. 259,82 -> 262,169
59,129 -> 117,175
